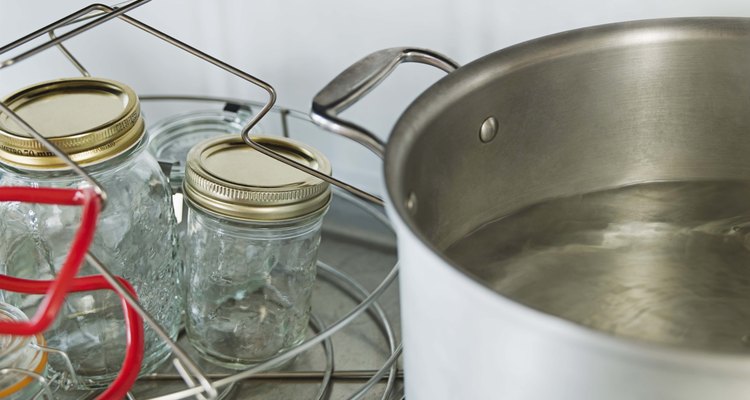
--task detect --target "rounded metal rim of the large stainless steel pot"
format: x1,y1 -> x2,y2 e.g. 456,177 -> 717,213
384,17 -> 750,362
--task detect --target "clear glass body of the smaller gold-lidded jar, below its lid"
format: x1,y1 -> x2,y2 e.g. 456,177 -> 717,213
183,203 -> 327,369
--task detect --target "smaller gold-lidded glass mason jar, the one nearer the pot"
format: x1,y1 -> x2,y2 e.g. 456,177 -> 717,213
183,136 -> 331,369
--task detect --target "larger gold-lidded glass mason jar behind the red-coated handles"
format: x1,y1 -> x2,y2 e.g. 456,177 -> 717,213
0,78 -> 183,389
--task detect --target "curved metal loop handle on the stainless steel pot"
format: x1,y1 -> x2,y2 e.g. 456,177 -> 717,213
310,47 -> 459,159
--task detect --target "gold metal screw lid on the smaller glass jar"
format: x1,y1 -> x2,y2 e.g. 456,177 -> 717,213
183,136 -> 331,221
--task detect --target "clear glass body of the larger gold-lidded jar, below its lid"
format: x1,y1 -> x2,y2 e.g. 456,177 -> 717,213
0,140 -> 183,389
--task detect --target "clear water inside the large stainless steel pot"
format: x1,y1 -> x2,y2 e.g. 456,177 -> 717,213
446,181 -> 750,354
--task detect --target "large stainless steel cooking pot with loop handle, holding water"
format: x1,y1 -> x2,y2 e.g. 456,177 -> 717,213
313,18 -> 750,400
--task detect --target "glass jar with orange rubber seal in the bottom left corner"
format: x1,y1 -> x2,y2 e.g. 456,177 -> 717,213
0,302 -> 47,400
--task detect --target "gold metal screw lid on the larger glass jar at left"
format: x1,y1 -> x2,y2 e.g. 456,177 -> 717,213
0,78 -> 144,170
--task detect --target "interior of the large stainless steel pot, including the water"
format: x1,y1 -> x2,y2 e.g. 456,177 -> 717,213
386,19 -> 750,353
